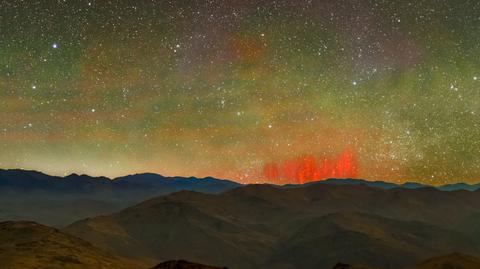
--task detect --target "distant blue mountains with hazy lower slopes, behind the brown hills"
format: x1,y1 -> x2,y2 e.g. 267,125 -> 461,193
0,169 -> 480,227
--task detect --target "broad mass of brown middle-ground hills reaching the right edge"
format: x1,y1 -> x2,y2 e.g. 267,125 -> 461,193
64,184 -> 480,269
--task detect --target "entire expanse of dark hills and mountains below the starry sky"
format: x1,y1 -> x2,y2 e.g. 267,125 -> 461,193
0,170 -> 480,269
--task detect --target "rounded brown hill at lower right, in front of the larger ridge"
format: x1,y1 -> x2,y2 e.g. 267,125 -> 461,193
266,213 -> 474,268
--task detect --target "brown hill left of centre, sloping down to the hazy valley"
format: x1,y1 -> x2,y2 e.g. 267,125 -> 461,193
65,192 -> 274,268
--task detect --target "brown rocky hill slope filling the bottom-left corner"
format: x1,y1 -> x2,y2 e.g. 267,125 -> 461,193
0,221 -> 137,269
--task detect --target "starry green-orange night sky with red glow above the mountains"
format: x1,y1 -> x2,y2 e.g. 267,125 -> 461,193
0,0 -> 480,185
